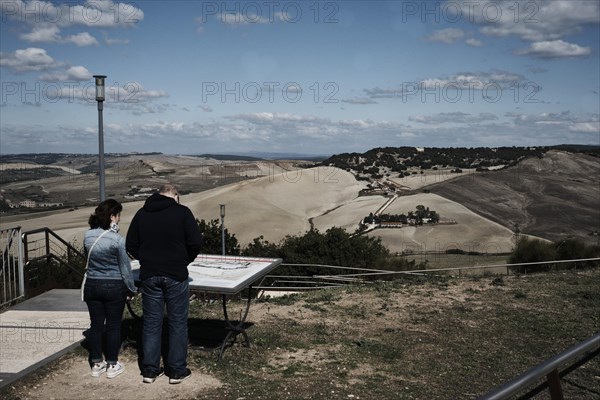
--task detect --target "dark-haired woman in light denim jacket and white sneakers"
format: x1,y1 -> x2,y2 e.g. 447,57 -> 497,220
83,199 -> 137,378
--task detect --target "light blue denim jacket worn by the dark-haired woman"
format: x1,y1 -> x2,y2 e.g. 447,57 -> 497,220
83,228 -> 137,293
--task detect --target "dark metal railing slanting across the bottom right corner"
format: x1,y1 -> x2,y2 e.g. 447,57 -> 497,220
478,333 -> 600,400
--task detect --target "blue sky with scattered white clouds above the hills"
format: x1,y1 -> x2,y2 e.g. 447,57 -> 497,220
0,0 -> 600,155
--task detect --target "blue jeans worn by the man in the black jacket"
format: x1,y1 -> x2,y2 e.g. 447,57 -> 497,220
141,276 -> 190,376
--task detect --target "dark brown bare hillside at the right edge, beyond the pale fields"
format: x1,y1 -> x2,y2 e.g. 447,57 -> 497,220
428,151 -> 600,244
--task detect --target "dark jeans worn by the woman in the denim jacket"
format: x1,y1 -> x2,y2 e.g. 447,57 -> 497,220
83,278 -> 127,364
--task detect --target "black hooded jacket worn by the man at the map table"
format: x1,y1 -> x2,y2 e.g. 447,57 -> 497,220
126,193 -> 203,282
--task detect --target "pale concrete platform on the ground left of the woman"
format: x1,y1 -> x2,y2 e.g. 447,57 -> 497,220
0,289 -> 90,387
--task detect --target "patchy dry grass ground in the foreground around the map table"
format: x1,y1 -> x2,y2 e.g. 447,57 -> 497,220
0,269 -> 600,400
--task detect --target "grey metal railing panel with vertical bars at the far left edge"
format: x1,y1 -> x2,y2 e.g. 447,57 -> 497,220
0,227 -> 25,307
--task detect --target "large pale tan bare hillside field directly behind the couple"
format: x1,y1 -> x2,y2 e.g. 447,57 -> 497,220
0,163 -> 365,245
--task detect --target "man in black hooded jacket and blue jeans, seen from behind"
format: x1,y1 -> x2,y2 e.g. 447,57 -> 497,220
126,184 -> 202,383
